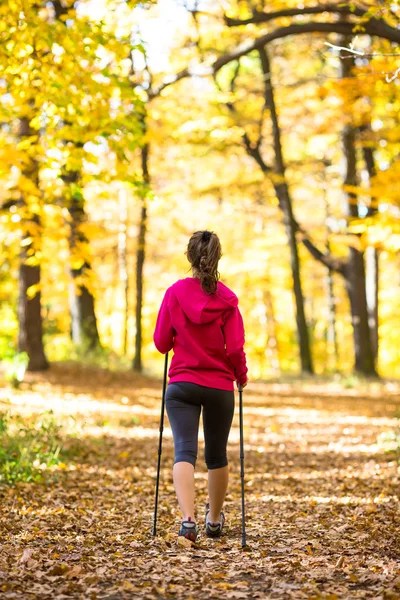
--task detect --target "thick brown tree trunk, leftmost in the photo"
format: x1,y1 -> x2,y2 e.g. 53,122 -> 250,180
18,117 -> 49,371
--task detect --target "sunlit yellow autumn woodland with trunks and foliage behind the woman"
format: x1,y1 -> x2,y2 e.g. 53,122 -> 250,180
0,0 -> 400,378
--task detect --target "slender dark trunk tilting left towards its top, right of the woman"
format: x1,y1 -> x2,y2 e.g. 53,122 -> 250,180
259,48 -> 313,373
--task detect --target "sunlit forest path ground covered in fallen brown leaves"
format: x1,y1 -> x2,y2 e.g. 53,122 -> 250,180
0,367 -> 400,600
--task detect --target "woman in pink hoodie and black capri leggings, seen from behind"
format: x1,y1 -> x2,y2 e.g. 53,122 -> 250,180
154,231 -> 247,543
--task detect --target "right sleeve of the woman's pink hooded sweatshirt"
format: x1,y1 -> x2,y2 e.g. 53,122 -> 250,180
223,307 -> 247,384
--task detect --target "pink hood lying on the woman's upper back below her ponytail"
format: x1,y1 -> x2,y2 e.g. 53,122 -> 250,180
172,277 -> 238,325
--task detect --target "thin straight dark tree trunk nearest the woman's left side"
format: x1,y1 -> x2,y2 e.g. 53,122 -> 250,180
132,143 -> 150,372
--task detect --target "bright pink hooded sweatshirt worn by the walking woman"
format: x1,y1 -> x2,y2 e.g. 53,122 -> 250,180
154,277 -> 247,390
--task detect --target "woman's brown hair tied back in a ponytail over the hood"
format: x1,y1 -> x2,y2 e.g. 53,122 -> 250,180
186,231 -> 222,294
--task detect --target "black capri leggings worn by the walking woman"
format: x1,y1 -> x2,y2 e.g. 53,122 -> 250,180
165,382 -> 235,469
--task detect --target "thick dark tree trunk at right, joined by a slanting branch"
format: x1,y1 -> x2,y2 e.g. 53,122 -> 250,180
340,47 -> 376,376
